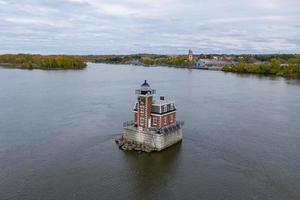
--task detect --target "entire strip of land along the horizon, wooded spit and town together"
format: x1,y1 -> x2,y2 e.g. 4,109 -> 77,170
0,54 -> 300,78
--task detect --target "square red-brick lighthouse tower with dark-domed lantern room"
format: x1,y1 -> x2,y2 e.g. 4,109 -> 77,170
134,80 -> 155,131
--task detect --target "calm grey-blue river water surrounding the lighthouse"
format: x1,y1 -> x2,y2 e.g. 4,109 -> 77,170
0,64 -> 300,200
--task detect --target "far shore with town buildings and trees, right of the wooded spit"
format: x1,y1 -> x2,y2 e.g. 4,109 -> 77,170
83,54 -> 300,78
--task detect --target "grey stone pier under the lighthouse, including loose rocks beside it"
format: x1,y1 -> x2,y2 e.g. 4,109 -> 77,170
116,127 -> 182,152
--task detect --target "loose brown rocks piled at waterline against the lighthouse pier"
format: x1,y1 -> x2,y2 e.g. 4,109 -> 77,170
115,136 -> 155,153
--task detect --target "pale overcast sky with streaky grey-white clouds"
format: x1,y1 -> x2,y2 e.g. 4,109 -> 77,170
0,0 -> 300,54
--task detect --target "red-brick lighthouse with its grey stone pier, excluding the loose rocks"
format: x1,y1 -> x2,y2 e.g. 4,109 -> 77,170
122,80 -> 184,151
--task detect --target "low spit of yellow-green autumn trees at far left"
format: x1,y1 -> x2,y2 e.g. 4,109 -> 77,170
0,54 -> 86,70
